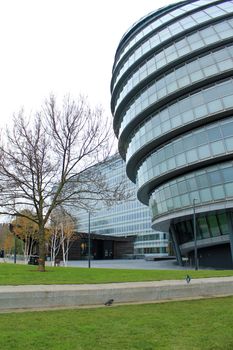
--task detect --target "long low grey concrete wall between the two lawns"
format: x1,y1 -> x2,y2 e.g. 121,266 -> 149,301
0,277 -> 233,312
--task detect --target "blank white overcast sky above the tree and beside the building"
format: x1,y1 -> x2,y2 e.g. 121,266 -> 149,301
0,0 -> 176,126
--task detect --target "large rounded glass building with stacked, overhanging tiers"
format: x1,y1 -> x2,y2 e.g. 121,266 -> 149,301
111,0 -> 233,268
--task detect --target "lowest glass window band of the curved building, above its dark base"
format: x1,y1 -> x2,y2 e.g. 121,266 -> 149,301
149,162 -> 233,219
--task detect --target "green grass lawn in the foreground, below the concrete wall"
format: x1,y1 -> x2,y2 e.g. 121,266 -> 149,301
0,297 -> 233,350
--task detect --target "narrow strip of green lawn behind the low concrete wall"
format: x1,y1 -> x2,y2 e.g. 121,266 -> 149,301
0,263 -> 233,285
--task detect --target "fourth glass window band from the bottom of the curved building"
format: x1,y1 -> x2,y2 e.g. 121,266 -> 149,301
120,46 -> 233,139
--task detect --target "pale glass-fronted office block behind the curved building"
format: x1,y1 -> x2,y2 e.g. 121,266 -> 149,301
70,155 -> 168,258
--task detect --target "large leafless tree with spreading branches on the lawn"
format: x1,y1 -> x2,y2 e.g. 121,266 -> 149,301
0,96 -> 128,271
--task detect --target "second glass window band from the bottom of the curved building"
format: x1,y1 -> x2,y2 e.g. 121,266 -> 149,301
137,117 -> 233,189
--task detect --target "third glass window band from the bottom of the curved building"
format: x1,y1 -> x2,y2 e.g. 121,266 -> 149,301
126,79 -> 233,162
